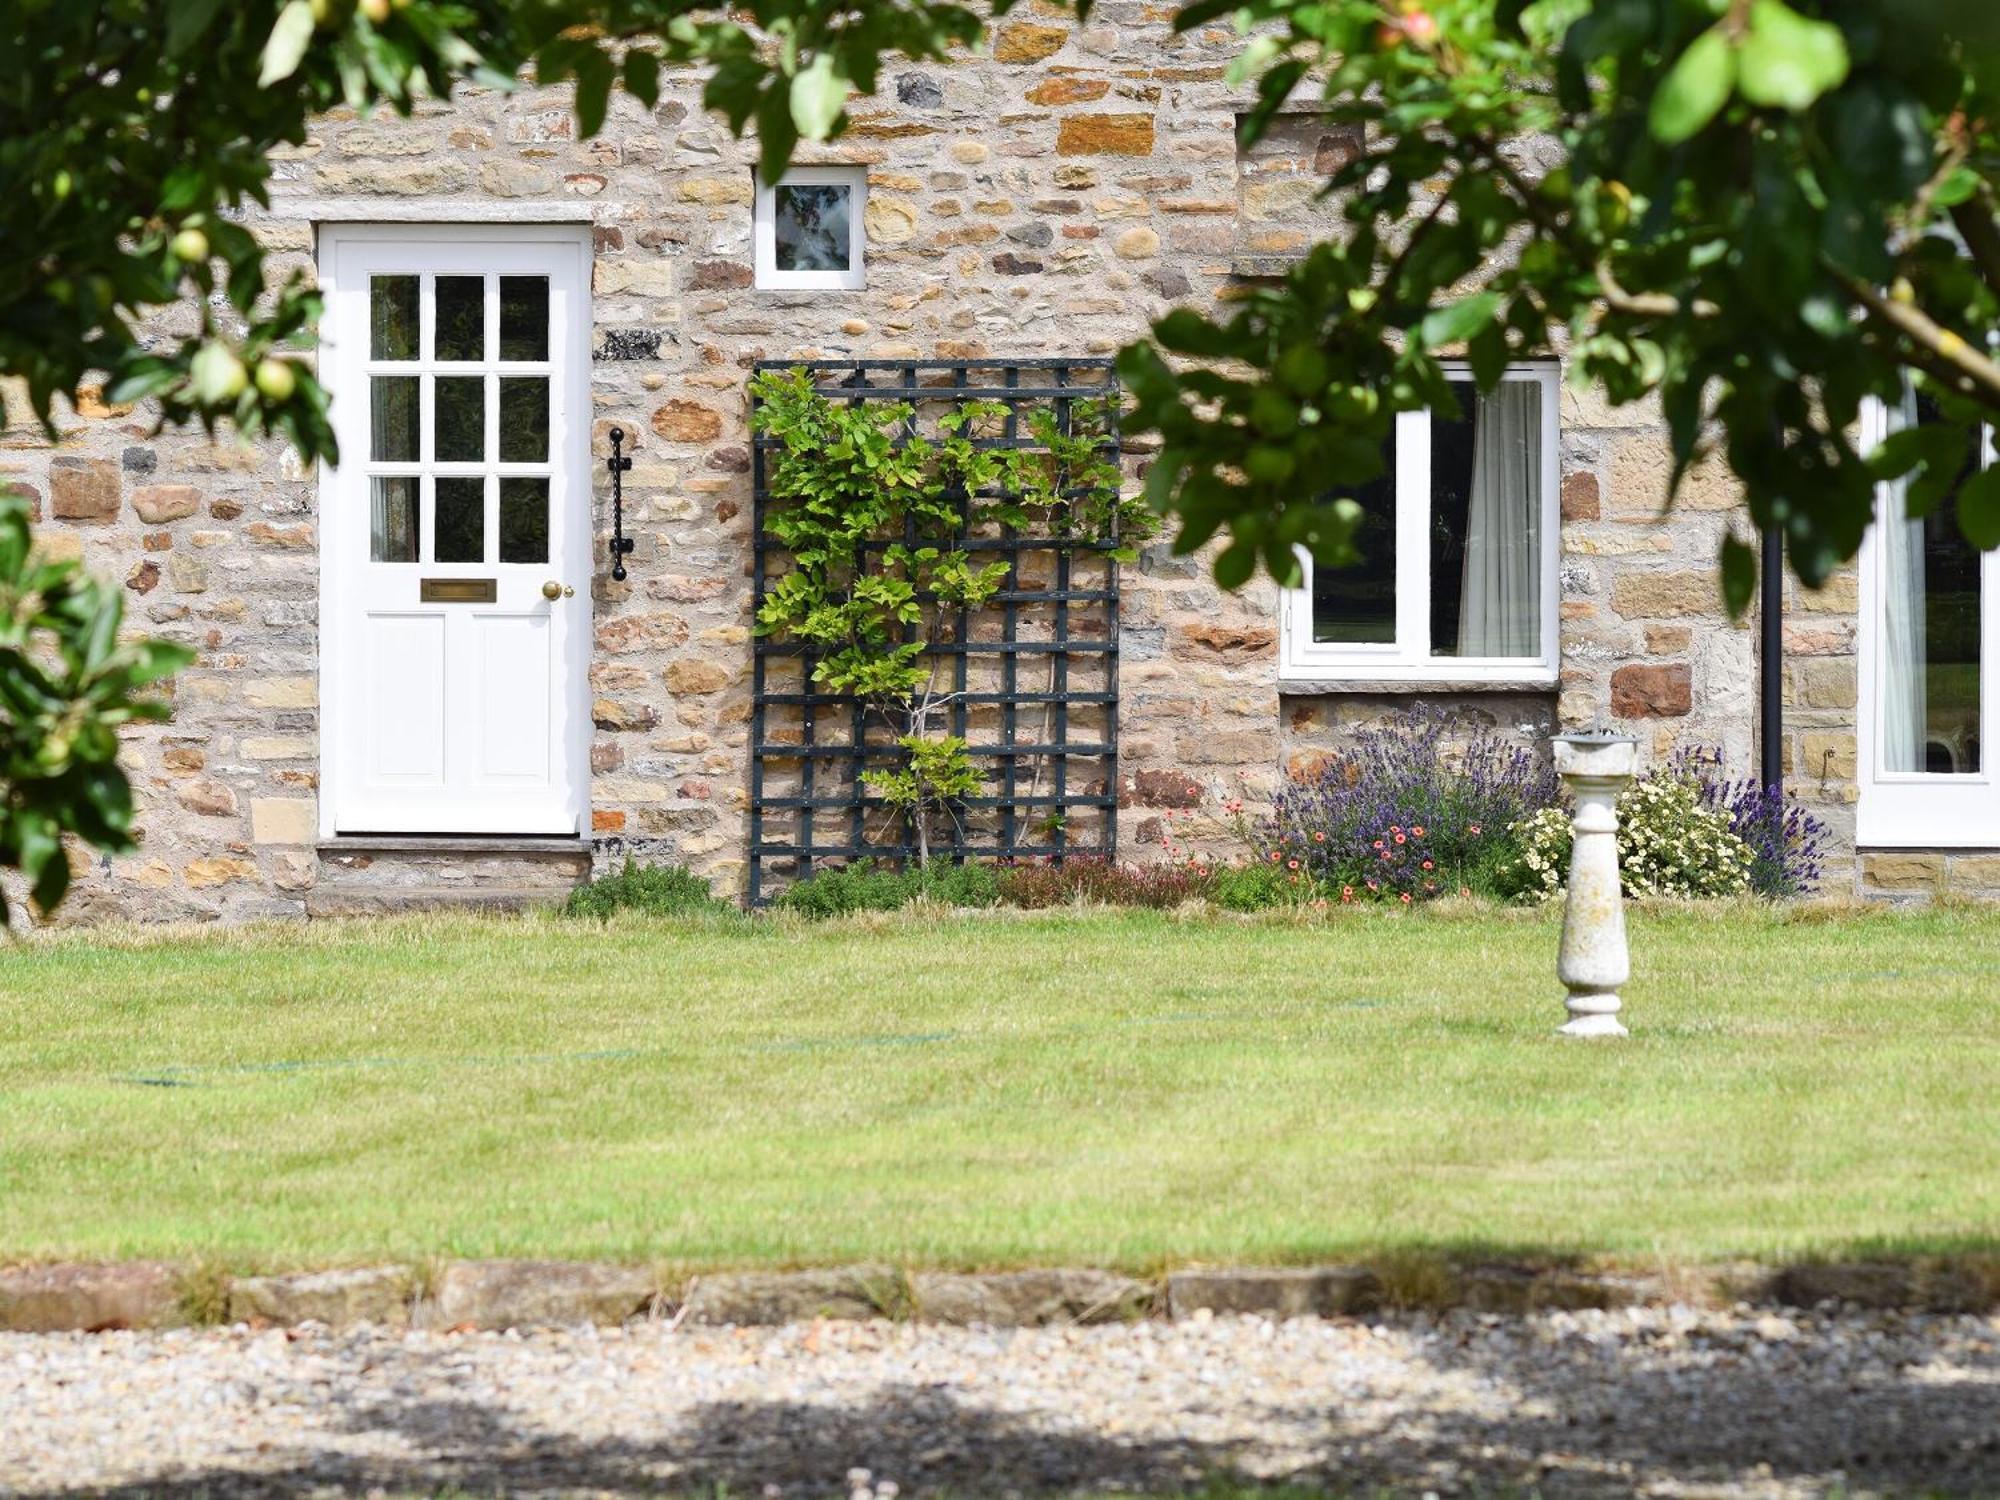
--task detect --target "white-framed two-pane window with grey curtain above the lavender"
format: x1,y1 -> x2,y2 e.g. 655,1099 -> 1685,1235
1280,366 -> 1560,684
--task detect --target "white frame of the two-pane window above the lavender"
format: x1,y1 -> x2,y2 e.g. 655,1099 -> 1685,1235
1278,364 -> 1562,686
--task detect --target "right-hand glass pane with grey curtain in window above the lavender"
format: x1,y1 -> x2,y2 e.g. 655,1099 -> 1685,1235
1430,380 -> 1542,656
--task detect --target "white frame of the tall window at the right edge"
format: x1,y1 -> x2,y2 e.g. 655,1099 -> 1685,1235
1848,400 -> 2000,848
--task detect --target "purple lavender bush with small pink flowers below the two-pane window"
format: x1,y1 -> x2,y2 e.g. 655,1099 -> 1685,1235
1230,708 -> 1560,904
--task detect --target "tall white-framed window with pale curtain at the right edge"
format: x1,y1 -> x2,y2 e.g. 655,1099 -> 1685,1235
1848,394 -> 2000,848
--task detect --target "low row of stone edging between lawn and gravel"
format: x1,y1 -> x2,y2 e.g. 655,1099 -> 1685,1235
0,1258 -> 2000,1332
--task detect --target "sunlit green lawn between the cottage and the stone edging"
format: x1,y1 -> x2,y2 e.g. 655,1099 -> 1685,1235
0,908 -> 2000,1270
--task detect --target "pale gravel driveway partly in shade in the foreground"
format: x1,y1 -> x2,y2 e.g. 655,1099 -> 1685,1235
0,1308 -> 2000,1500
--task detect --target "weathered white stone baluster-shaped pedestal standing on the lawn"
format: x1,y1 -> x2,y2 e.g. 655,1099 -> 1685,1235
1552,730 -> 1638,1036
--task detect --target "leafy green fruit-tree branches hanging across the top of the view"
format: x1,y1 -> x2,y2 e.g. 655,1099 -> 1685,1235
0,0 -> 2000,604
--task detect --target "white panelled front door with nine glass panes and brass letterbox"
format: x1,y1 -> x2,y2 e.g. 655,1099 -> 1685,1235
320,226 -> 590,836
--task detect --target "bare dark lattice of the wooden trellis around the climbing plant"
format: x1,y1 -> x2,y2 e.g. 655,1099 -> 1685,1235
750,358 -> 1120,906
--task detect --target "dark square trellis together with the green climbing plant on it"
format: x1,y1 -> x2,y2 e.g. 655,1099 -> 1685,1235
750,360 -> 1152,904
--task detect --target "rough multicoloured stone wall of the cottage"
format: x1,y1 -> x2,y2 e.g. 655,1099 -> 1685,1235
15,0 -> 1968,918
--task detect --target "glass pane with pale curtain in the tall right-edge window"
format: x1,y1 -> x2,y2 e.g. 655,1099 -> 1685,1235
1878,400 -> 1984,776
